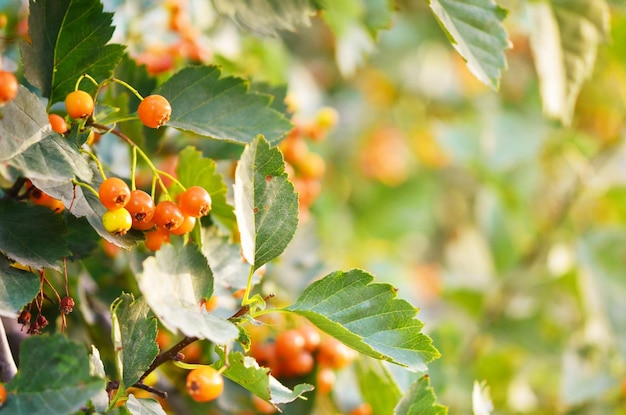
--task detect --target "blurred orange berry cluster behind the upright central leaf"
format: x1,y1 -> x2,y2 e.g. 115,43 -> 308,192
279,107 -> 339,220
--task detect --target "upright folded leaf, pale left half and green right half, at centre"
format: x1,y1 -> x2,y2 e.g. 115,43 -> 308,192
234,136 -> 298,269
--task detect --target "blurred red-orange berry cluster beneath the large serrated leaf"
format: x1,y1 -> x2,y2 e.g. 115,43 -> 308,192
250,323 -> 356,393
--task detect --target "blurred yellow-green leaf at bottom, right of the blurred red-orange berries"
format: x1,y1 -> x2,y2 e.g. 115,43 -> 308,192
354,357 -> 402,414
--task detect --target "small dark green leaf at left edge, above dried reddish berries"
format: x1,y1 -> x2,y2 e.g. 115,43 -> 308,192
0,256 -> 39,318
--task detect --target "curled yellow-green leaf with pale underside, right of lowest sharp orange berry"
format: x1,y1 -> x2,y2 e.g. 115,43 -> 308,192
218,350 -> 313,405
